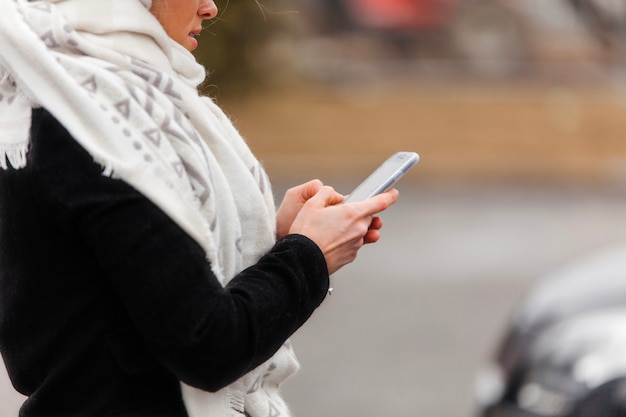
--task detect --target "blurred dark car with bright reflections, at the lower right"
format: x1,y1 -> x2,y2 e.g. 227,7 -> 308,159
476,245 -> 626,417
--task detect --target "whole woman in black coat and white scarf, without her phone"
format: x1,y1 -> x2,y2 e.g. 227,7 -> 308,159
0,0 -> 397,417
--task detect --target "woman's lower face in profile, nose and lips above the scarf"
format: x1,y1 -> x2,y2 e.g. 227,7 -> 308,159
150,0 -> 217,51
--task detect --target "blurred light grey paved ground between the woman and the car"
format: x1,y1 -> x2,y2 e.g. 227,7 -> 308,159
276,180 -> 626,417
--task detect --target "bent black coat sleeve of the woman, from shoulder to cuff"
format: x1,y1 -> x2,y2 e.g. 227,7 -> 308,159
29,110 -> 328,391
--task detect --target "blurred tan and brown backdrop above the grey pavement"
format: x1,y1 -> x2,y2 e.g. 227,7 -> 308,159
197,0 -> 626,185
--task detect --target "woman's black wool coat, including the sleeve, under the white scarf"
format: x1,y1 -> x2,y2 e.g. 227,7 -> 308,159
0,109 -> 328,417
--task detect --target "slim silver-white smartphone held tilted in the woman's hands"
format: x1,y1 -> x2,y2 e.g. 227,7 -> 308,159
344,152 -> 420,204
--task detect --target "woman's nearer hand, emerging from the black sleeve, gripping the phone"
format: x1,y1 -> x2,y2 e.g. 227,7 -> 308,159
289,187 -> 398,274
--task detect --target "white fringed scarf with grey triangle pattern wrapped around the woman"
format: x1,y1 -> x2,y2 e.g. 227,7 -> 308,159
0,0 -> 298,417
